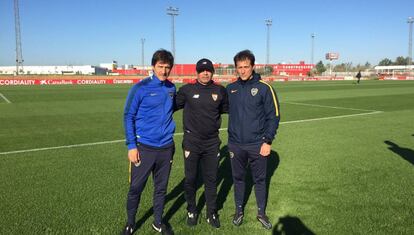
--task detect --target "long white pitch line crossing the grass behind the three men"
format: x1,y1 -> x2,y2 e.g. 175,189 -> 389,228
0,111 -> 383,155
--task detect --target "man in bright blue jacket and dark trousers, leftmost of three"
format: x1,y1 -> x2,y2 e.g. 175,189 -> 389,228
122,49 -> 176,234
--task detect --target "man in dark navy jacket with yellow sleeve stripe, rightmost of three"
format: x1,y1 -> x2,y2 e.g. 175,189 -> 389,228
227,50 -> 280,229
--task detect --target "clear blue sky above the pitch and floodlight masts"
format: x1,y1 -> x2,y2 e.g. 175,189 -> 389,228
0,0 -> 414,66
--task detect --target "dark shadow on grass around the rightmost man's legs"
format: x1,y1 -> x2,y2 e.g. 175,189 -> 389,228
244,150 -> 280,211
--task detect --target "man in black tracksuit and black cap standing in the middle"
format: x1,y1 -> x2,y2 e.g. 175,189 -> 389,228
176,59 -> 228,228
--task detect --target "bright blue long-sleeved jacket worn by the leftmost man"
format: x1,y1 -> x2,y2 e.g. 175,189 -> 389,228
124,75 -> 176,149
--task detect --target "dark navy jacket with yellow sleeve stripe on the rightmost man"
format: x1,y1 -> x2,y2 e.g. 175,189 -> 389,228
226,73 -> 280,145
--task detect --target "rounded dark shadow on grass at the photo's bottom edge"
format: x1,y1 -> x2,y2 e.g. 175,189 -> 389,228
272,215 -> 315,235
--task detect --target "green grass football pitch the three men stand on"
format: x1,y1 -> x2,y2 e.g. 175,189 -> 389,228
0,81 -> 414,235
